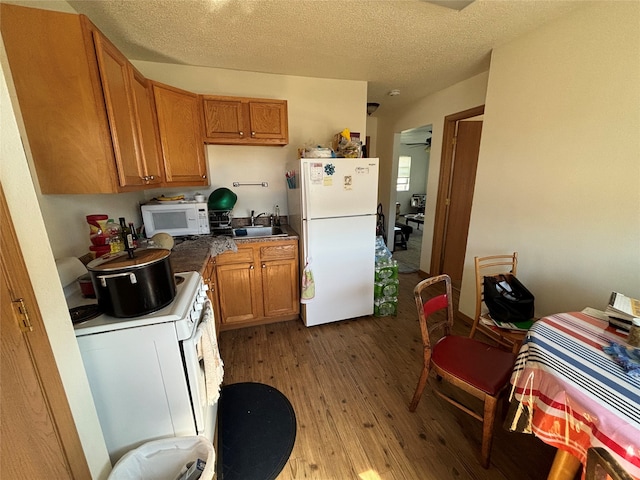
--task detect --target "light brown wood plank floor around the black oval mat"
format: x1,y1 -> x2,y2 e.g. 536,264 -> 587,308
220,274 -> 555,480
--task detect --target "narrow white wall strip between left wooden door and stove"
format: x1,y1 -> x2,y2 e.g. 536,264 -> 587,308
0,54 -> 111,479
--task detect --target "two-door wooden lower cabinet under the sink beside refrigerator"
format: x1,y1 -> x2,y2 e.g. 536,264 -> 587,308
210,240 -> 300,330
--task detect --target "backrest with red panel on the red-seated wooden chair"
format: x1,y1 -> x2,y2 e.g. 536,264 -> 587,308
413,275 -> 453,348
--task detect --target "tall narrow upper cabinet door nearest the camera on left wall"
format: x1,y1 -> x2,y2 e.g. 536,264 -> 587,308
93,30 -> 144,187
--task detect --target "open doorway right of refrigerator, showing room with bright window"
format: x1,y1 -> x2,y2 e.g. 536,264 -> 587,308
392,125 -> 433,273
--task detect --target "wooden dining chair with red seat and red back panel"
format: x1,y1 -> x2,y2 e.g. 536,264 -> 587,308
409,275 -> 516,468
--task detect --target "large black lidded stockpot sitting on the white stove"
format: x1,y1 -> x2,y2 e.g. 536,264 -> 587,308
87,248 -> 176,318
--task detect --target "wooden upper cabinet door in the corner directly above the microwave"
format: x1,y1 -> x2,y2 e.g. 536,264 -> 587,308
151,82 -> 209,186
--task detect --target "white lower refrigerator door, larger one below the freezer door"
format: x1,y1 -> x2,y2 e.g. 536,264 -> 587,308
302,215 -> 376,327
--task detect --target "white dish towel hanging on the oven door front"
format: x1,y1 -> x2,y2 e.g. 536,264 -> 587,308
197,300 -> 224,405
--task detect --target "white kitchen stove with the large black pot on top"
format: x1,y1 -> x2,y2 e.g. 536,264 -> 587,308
58,263 -> 222,464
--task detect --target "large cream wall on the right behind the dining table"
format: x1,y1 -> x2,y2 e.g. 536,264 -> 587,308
460,2 -> 640,316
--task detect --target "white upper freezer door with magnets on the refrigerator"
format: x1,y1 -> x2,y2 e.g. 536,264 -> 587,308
302,158 -> 378,219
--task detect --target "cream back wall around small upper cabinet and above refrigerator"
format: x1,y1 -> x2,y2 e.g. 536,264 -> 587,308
133,61 -> 367,223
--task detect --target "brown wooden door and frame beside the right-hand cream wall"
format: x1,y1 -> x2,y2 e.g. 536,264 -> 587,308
430,105 -> 484,289
